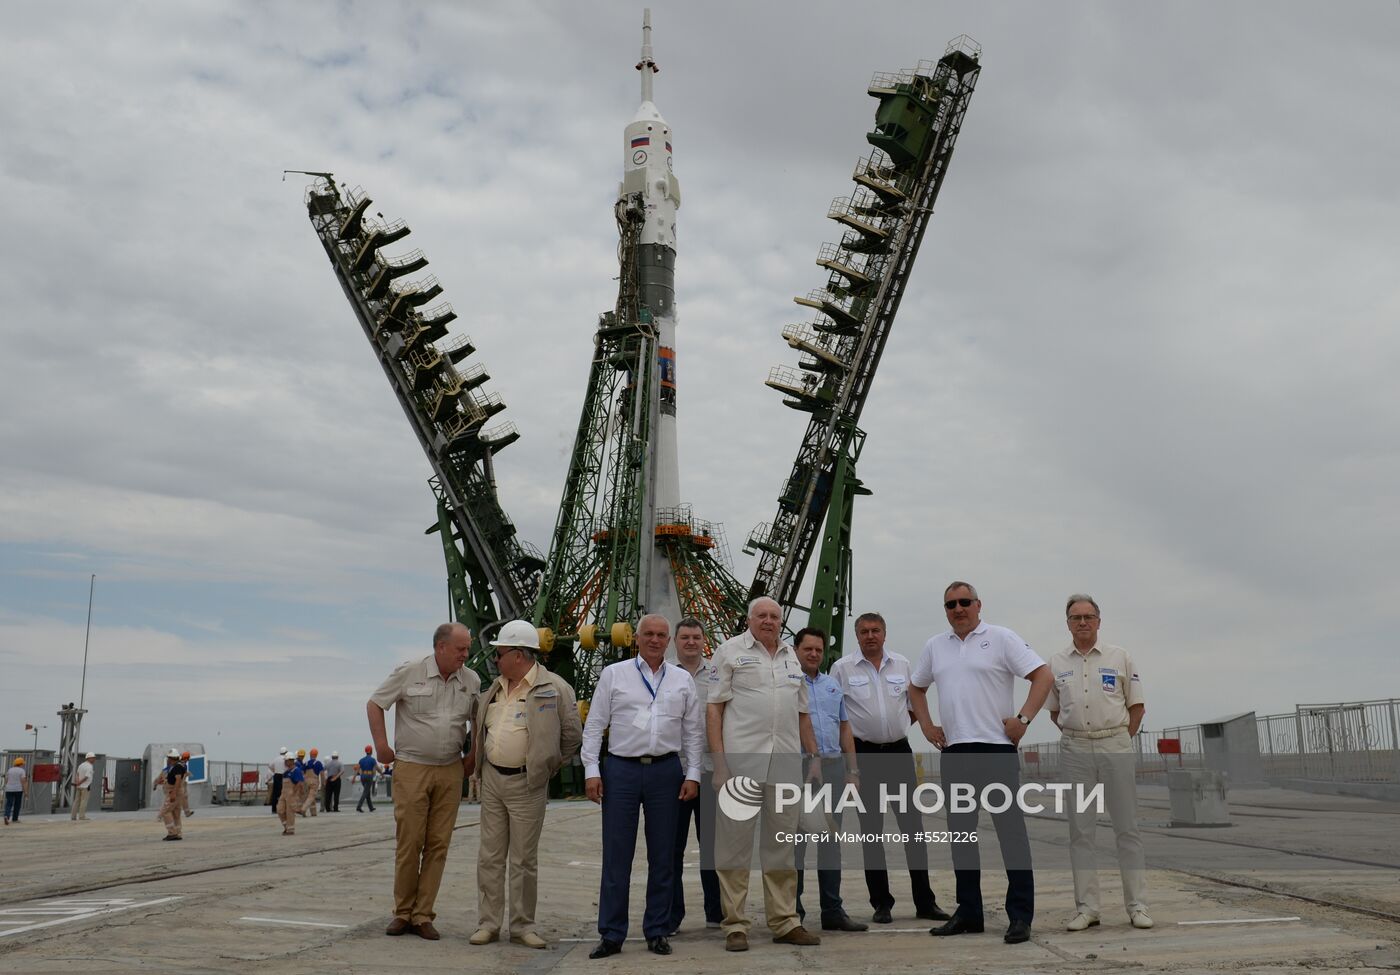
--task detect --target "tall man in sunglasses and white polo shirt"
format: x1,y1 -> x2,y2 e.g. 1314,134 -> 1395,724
909,581 -> 1054,944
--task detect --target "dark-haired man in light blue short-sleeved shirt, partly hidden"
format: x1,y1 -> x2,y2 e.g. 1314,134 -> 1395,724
792,626 -> 868,932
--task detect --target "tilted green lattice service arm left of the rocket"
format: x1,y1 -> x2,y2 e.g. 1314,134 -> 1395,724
298,172 -> 545,646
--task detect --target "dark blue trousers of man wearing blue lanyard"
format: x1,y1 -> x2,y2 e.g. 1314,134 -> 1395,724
598,755 -> 685,941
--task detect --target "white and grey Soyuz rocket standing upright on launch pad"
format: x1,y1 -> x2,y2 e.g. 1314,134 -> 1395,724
617,10 -> 680,630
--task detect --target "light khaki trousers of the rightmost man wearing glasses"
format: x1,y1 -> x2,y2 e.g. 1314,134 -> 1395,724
1060,728 -> 1147,916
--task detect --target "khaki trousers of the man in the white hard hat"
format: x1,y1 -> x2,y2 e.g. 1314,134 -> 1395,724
476,762 -> 549,937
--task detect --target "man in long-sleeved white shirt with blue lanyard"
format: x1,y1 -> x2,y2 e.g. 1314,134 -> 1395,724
581,614 -> 704,958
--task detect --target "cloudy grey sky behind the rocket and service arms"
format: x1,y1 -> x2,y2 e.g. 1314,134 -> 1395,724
0,0 -> 1400,761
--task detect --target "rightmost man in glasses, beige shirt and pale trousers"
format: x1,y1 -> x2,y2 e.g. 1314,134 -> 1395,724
1046,593 -> 1152,932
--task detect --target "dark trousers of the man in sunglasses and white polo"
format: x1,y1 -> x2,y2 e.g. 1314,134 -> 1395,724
939,741 -> 1036,925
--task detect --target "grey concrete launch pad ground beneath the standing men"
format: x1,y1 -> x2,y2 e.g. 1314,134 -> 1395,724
0,789 -> 1400,975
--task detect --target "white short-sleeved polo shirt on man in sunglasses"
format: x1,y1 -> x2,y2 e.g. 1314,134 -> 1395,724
910,623 -> 1044,745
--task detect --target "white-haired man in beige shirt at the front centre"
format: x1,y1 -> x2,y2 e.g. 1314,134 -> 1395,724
706,597 -> 822,951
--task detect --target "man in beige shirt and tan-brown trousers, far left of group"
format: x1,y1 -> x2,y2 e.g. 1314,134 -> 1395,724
365,623 -> 482,941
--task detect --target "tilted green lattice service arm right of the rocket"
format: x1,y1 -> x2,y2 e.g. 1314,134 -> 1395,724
745,35 -> 981,653
